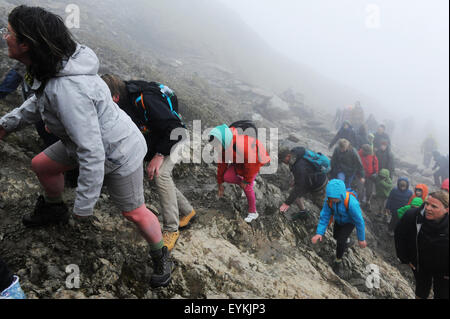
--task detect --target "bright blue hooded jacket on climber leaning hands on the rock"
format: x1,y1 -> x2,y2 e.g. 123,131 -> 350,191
316,179 -> 366,241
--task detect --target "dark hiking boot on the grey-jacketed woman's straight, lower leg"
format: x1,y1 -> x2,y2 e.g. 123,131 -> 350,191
150,246 -> 173,288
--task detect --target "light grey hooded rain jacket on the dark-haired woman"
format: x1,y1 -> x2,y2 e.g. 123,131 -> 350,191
0,45 -> 147,216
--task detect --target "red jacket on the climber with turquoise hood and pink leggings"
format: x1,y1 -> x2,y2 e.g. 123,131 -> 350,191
217,127 -> 270,184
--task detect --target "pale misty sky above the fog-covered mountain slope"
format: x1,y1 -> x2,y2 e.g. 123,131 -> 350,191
217,0 -> 449,147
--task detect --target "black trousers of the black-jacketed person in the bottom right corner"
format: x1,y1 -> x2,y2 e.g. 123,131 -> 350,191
413,269 -> 449,299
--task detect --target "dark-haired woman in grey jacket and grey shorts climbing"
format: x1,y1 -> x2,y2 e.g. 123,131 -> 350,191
0,6 -> 172,287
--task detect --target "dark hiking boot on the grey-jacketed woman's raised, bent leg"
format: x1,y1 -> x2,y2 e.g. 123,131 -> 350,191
22,195 -> 69,227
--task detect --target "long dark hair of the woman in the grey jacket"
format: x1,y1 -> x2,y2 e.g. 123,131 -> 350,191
8,5 -> 77,83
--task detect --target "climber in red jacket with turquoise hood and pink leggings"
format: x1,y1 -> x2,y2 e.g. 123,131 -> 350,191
209,124 -> 270,223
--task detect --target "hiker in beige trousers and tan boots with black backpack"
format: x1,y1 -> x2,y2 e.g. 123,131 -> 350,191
102,74 -> 196,251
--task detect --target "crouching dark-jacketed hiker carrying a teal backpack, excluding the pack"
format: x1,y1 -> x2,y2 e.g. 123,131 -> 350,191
280,147 -> 328,218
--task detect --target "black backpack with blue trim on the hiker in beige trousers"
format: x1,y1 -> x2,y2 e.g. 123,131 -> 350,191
126,81 -> 186,133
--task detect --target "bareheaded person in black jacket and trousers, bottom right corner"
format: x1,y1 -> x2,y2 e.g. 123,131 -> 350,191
395,191 -> 449,299
